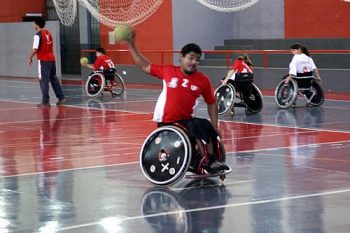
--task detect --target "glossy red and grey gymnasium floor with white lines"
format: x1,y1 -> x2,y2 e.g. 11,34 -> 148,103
0,75 -> 350,233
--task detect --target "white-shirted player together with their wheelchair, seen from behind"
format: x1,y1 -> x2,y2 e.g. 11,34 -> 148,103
275,44 -> 324,108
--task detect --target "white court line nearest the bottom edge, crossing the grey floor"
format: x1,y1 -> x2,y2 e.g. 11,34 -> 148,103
55,189 -> 350,232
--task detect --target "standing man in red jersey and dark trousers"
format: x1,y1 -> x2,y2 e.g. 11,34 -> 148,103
28,17 -> 65,107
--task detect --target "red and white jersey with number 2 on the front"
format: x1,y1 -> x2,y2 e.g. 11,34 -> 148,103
151,64 -> 215,123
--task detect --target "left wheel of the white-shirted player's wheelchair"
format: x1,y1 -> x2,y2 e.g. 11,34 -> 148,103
275,79 -> 298,108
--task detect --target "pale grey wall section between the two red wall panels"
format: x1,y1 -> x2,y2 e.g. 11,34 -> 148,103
172,0 -> 284,50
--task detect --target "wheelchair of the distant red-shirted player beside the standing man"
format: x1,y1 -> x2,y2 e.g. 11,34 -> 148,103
85,68 -> 125,97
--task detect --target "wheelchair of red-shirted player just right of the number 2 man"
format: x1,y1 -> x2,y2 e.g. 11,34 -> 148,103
215,77 -> 263,115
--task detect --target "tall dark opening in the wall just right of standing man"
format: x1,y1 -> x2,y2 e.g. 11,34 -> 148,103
46,0 -> 80,74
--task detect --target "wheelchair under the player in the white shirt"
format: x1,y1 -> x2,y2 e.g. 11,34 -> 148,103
275,76 -> 324,108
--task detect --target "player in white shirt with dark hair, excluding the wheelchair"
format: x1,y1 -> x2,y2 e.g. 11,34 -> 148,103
285,44 -> 321,84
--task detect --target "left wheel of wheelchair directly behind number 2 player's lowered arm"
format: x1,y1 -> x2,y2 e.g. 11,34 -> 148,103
215,84 -> 236,115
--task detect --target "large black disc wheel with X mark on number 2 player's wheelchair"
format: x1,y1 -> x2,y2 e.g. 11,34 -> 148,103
140,126 -> 192,186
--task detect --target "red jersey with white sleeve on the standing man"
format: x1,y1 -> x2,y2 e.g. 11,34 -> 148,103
33,29 -> 55,61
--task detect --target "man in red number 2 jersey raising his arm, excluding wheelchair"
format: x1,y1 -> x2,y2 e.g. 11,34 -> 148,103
128,33 -> 229,172
